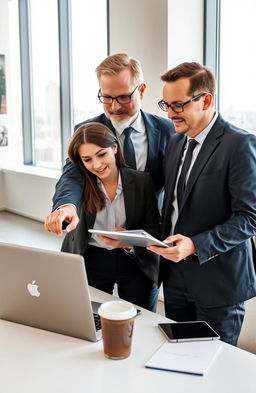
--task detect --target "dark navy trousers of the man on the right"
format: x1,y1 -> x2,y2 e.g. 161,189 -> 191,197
164,268 -> 245,345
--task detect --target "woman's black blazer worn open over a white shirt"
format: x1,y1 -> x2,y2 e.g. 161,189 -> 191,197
61,168 -> 160,283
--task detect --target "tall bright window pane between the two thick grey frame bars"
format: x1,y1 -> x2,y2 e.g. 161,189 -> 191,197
30,0 -> 61,169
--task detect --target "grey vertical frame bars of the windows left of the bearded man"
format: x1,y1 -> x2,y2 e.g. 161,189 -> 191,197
19,0 -> 109,166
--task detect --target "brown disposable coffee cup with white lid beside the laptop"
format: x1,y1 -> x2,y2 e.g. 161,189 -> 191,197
98,300 -> 137,360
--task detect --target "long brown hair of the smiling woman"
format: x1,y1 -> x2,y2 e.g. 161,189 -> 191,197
68,122 -> 126,213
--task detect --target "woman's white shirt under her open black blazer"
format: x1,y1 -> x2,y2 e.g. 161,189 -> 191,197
89,172 -> 126,250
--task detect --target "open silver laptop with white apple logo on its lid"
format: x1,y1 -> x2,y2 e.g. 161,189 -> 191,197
0,243 -> 101,341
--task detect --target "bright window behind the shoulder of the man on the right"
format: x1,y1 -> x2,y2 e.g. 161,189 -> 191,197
205,0 -> 256,134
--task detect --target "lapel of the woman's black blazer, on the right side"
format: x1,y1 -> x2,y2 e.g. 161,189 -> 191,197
120,168 -> 136,229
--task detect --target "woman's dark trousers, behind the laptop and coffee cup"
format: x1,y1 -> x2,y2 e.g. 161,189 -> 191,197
84,245 -> 159,312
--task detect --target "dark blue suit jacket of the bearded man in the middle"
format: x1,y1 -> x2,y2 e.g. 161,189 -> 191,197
53,111 -> 175,210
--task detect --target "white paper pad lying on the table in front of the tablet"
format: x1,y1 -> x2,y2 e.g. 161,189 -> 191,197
145,340 -> 222,376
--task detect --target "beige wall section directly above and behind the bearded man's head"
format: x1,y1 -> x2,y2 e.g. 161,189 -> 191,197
110,0 -> 168,114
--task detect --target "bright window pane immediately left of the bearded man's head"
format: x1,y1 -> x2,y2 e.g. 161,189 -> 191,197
71,0 -> 107,124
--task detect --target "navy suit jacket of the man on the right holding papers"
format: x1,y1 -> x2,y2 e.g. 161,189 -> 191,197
162,116 -> 256,307
